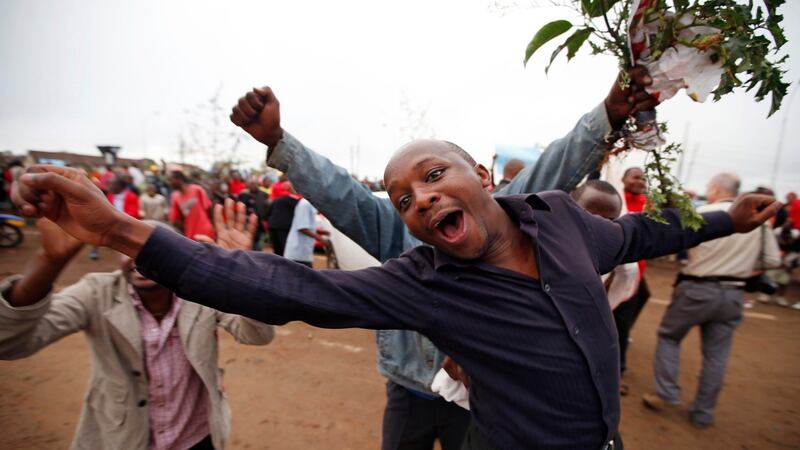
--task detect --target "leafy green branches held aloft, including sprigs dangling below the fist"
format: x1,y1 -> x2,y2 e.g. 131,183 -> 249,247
525,0 -> 789,225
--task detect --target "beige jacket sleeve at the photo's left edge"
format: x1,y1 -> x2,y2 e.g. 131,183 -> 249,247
0,276 -> 93,360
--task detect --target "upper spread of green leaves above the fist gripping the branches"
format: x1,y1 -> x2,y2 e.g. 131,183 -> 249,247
525,0 -> 789,116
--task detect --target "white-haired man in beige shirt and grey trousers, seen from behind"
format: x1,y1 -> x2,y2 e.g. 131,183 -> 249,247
642,173 -> 780,428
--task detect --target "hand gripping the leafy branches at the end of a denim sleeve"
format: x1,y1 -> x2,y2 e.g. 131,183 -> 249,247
605,66 -> 658,130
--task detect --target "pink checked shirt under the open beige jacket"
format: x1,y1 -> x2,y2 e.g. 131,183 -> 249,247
130,288 -> 209,450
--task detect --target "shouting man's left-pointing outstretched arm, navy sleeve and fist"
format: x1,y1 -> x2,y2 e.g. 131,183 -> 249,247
12,166 -> 434,329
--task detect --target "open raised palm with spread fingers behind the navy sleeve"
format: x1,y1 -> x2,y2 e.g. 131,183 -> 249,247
194,198 -> 258,251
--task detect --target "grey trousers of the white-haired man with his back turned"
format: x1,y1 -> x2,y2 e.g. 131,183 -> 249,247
653,281 -> 744,425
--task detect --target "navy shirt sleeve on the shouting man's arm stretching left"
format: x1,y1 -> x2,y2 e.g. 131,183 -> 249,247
136,228 -> 433,330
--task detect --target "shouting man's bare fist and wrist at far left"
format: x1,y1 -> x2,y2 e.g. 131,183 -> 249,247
11,165 -> 153,257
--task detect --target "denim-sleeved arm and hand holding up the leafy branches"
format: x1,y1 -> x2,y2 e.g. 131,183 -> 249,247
497,67 -> 658,195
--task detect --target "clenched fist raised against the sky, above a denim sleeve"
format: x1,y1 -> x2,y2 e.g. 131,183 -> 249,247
231,86 -> 283,147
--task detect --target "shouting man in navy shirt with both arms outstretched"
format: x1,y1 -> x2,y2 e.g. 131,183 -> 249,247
13,141 -> 780,450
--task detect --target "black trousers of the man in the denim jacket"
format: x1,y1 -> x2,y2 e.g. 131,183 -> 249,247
381,381 -> 470,450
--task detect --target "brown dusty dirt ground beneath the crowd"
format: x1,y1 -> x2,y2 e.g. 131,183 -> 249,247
0,233 -> 800,450
